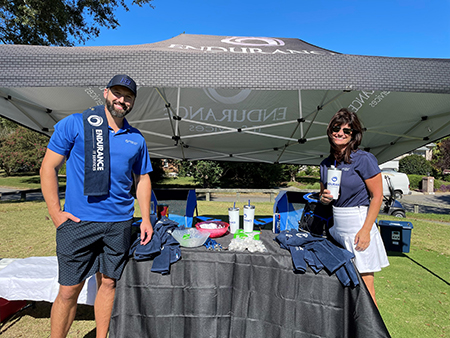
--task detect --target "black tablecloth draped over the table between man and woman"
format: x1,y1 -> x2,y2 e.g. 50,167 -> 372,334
110,231 -> 390,338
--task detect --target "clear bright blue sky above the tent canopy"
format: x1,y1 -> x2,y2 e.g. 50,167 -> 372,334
80,0 -> 450,58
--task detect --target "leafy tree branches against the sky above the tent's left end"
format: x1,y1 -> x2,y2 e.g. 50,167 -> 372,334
0,0 -> 153,46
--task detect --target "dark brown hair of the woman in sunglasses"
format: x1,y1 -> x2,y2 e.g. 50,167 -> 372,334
327,108 -> 363,163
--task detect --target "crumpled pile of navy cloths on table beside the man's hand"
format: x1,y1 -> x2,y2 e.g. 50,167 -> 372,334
129,216 -> 181,275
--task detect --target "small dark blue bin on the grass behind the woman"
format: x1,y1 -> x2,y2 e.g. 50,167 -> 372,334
378,221 -> 413,253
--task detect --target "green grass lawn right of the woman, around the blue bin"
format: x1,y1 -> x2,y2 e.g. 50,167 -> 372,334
375,213 -> 450,338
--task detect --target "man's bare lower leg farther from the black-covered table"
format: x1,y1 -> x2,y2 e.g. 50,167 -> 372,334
50,282 -> 84,338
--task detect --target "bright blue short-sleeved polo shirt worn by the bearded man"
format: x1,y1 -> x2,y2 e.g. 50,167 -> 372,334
48,114 -> 152,222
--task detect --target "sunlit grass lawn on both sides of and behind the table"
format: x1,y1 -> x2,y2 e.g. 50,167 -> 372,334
0,183 -> 450,338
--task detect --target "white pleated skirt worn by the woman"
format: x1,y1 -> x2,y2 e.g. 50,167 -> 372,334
330,206 -> 389,273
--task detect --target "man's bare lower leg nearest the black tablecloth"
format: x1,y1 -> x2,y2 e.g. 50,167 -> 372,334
94,273 -> 116,338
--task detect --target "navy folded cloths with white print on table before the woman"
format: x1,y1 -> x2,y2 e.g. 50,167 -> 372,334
274,230 -> 359,286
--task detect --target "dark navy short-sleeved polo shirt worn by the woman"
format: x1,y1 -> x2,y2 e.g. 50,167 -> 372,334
320,149 -> 381,207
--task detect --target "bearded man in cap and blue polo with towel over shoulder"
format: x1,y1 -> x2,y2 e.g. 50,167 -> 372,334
41,75 -> 153,338
